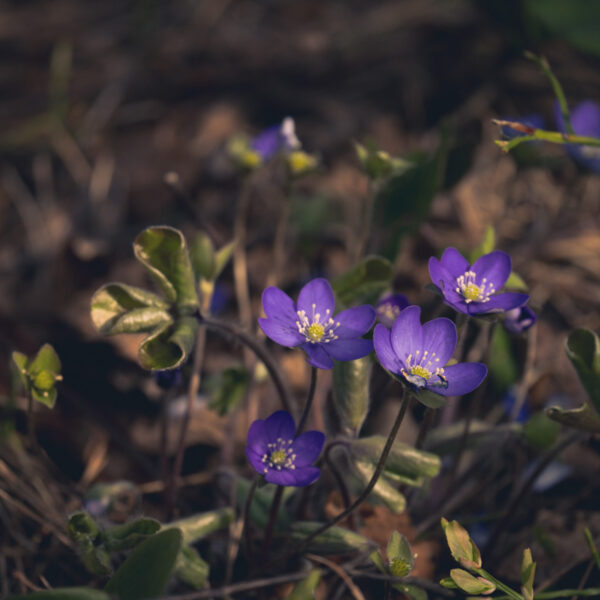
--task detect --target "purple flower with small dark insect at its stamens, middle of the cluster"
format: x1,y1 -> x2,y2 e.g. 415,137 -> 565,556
373,306 -> 487,396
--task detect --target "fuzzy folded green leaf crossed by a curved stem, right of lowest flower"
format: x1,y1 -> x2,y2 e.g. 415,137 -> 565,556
349,435 -> 441,486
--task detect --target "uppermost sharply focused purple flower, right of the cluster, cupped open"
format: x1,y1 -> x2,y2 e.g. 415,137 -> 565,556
429,248 -> 529,316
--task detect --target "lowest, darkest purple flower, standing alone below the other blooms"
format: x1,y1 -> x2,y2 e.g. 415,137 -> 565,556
246,410 -> 325,487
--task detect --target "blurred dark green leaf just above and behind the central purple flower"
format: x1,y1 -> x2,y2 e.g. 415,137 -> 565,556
332,256 -> 393,306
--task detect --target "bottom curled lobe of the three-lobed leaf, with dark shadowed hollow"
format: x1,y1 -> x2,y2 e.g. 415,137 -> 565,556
138,317 -> 198,370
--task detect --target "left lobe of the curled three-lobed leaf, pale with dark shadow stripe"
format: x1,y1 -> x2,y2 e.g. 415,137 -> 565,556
91,283 -> 172,335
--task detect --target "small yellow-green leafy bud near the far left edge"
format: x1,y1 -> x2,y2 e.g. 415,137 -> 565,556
12,344 -> 62,408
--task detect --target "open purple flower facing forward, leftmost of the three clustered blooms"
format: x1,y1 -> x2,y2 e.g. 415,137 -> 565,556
258,278 -> 375,369
